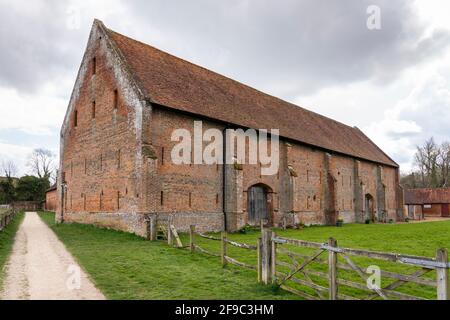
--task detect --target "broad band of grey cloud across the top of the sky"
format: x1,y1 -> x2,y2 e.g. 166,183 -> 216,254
0,0 -> 450,99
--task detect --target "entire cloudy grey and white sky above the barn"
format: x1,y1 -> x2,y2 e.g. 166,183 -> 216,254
0,0 -> 450,174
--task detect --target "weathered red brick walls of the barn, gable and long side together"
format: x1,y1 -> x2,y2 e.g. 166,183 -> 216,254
57,22 -> 402,235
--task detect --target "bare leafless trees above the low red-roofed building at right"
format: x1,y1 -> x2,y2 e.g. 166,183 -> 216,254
401,138 -> 450,189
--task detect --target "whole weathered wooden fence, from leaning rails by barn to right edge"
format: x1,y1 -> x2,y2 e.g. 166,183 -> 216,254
147,218 -> 450,300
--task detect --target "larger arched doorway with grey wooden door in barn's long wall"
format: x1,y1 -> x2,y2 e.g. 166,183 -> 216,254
247,184 -> 272,226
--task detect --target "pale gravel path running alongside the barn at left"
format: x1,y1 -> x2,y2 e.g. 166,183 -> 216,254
0,212 -> 105,300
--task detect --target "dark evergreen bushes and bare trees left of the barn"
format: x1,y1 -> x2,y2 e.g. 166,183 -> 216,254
0,149 -> 56,204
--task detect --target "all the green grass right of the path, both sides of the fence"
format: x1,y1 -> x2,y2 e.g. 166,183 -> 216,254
41,213 -> 450,299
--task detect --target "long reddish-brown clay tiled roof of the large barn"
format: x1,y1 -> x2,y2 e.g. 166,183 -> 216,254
104,25 -> 398,167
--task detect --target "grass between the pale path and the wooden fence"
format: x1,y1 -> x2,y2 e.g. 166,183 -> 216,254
40,212 -> 297,300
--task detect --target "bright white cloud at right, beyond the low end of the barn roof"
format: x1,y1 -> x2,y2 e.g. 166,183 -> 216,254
364,65 -> 450,172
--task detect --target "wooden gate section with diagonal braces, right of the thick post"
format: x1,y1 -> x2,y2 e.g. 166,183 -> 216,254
262,230 -> 450,300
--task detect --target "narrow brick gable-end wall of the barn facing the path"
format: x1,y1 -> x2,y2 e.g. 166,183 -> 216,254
57,24 -> 144,234
